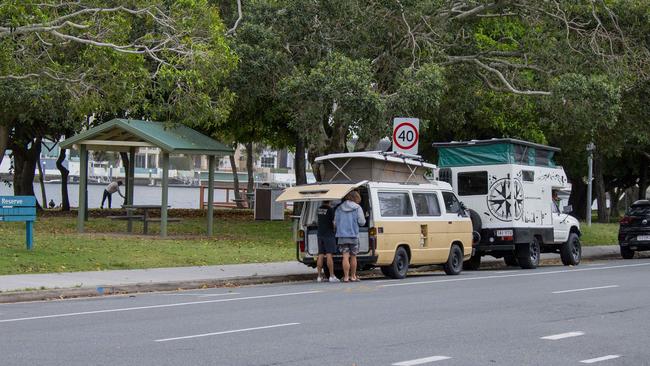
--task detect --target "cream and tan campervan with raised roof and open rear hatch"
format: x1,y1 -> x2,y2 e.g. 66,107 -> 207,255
277,152 -> 472,278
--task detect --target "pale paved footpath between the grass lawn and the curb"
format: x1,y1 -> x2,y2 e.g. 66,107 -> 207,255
0,245 -> 619,302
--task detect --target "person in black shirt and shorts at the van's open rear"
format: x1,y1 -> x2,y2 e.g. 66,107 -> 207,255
316,201 -> 339,282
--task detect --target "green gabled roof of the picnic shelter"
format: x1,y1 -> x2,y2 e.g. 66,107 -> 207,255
61,118 -> 233,155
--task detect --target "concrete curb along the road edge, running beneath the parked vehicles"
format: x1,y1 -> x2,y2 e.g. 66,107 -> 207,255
0,249 -> 620,304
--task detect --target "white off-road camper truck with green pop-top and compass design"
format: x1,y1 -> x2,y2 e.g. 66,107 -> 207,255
433,139 -> 582,269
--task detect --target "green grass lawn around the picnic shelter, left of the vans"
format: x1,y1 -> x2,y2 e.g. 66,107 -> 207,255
0,217 -> 295,275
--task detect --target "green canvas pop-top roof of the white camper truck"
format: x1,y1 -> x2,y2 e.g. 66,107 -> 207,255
433,139 -> 560,168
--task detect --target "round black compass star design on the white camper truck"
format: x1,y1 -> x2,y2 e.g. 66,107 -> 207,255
487,178 -> 524,221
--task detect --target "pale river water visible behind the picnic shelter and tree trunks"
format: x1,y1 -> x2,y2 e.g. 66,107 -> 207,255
0,183 -> 233,208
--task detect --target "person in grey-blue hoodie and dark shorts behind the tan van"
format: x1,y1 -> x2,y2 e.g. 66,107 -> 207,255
334,191 -> 366,282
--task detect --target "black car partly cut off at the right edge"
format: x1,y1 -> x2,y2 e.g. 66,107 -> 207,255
618,200 -> 650,259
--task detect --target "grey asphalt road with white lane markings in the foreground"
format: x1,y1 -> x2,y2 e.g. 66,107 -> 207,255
0,259 -> 650,366
